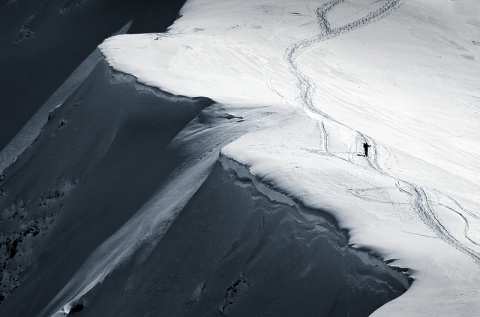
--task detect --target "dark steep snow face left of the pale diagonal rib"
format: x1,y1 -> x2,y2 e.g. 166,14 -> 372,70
0,59 -> 211,316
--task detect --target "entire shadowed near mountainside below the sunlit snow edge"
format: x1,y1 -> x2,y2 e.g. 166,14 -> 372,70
0,57 -> 408,317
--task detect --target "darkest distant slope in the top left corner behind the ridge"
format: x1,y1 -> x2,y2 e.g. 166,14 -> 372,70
0,0 -> 185,150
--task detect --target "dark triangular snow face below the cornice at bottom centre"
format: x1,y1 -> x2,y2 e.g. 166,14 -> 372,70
59,160 -> 408,316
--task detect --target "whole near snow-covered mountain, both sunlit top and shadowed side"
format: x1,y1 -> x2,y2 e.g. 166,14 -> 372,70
0,0 -> 480,316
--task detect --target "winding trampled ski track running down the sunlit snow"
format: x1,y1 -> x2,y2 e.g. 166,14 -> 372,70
285,0 -> 480,264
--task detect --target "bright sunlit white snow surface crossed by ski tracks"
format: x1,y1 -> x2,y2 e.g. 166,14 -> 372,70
100,0 -> 480,316
